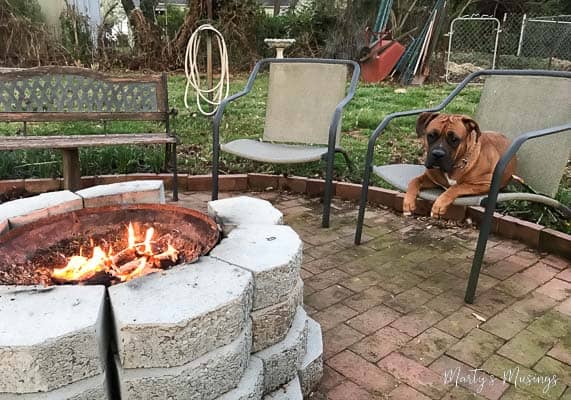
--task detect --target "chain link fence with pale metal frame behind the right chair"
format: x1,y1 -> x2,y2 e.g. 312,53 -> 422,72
446,14 -> 571,83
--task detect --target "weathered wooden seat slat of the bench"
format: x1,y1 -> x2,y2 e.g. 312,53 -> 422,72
0,133 -> 177,150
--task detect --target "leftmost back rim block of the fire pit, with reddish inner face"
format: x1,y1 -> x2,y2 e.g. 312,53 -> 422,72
0,190 -> 83,227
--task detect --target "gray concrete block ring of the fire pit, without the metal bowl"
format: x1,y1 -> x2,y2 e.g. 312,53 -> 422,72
0,181 -> 323,400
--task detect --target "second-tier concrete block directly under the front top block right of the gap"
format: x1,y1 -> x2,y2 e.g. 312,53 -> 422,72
117,325 -> 252,400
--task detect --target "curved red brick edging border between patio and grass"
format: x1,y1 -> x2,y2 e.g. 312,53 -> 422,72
0,173 -> 571,258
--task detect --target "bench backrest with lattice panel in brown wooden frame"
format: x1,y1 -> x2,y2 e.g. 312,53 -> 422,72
0,67 -> 168,122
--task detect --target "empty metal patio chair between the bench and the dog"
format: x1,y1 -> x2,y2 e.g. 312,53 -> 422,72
212,58 -> 360,227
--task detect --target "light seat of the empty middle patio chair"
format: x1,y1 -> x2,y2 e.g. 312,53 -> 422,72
220,139 -> 327,164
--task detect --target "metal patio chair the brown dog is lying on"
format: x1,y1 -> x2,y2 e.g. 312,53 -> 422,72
355,70 -> 571,304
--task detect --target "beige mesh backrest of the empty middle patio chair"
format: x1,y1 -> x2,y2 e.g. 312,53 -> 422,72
263,63 -> 347,144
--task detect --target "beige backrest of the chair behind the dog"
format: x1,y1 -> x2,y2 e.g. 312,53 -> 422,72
476,75 -> 571,197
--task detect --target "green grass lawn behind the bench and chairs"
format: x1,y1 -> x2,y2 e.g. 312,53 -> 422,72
0,74 -> 571,232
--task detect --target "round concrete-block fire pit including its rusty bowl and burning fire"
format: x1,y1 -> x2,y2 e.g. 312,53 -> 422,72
0,184 -> 323,400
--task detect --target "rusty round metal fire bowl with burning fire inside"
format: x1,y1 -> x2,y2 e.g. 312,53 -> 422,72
0,204 -> 219,286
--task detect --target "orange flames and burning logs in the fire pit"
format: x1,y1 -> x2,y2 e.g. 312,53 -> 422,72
52,223 -> 179,282
